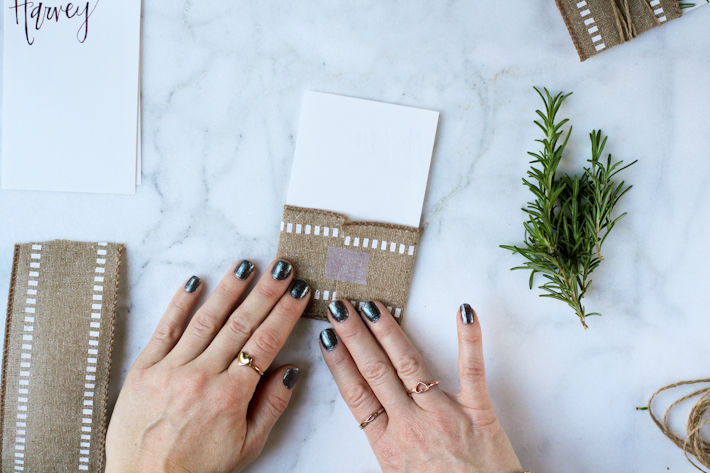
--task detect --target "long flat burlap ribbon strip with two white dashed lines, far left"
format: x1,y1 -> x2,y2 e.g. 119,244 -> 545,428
0,240 -> 123,473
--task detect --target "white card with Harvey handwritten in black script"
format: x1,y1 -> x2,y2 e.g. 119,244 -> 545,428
1,0 -> 141,194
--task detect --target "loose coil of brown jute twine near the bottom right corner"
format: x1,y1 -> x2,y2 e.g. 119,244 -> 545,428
648,379 -> 710,471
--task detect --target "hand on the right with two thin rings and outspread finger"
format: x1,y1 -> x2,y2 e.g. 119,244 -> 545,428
321,300 -> 522,473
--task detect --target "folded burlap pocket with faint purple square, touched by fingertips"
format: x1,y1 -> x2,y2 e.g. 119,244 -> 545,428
277,205 -> 419,324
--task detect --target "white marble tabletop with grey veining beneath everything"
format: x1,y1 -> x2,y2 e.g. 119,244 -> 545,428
0,0 -> 710,472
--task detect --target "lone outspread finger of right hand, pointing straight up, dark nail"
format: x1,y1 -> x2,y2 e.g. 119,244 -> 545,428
456,304 -> 495,422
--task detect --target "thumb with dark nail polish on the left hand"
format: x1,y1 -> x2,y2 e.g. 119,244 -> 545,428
245,365 -> 301,452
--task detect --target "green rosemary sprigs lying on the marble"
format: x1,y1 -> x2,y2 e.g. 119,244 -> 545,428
501,88 -> 636,329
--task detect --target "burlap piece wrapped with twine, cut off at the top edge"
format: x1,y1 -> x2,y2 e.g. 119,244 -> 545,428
555,0 -> 681,61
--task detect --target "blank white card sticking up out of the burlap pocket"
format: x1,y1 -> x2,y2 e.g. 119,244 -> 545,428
286,92 -> 439,227
